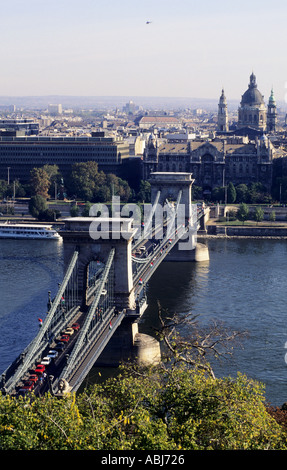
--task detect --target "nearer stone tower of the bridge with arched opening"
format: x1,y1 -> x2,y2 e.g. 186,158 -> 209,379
61,217 -> 135,310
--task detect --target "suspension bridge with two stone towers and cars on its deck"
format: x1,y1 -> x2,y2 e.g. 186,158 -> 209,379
1,173 -> 208,396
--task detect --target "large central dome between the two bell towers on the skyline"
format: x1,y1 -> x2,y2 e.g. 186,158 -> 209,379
238,72 -> 267,131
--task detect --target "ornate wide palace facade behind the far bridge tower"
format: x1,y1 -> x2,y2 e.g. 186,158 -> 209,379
143,135 -> 278,195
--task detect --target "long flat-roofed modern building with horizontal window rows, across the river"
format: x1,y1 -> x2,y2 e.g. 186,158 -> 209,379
0,133 -> 129,183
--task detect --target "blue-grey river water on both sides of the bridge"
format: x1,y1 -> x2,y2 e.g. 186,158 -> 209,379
0,239 -> 287,406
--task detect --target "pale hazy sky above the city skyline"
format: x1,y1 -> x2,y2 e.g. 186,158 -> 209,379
0,0 -> 287,100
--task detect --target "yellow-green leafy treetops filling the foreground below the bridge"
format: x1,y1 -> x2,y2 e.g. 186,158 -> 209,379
0,365 -> 286,450
